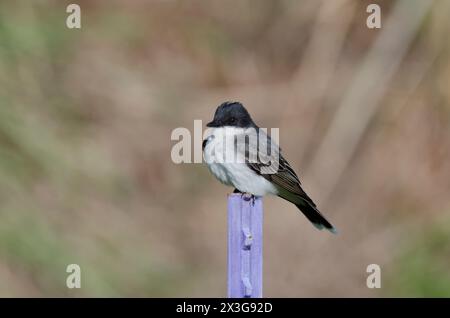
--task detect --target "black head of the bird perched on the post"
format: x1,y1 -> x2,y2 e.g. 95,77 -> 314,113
206,102 -> 256,128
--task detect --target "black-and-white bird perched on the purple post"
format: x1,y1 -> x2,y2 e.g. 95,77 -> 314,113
202,101 -> 337,234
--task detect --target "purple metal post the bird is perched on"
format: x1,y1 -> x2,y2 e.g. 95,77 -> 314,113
228,193 -> 263,298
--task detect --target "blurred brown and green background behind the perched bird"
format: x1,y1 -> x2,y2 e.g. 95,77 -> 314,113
0,0 -> 450,297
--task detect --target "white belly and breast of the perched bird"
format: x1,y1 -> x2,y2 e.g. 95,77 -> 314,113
204,128 -> 277,196
